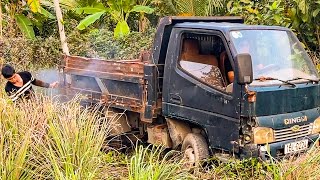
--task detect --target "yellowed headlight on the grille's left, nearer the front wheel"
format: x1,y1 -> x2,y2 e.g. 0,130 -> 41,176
253,127 -> 274,144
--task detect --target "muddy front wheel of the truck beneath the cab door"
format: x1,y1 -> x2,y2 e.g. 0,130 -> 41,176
181,133 -> 209,168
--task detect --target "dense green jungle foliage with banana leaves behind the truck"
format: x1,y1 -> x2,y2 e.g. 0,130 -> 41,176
0,0 -> 320,67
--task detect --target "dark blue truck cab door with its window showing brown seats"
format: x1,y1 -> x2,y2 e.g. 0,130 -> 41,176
163,28 -> 240,151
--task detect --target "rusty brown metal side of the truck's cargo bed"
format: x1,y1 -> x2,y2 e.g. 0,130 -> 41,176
62,52 -> 156,114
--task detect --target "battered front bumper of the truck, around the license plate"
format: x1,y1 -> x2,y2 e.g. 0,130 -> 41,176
240,134 -> 320,160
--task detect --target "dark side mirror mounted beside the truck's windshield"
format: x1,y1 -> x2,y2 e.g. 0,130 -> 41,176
235,53 -> 253,85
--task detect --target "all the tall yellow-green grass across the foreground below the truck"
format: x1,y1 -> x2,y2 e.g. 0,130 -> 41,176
0,85 -> 320,180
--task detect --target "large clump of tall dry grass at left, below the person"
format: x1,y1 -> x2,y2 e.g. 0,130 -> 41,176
0,93 -> 111,180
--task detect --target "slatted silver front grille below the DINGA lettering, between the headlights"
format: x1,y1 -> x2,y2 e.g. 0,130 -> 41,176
274,123 -> 312,141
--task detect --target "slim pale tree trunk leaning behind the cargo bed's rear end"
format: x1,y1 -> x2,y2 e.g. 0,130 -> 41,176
53,0 -> 69,55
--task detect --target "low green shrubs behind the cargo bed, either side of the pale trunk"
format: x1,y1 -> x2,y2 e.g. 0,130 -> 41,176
0,29 -> 155,69
